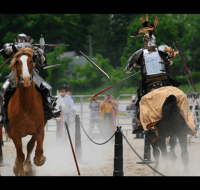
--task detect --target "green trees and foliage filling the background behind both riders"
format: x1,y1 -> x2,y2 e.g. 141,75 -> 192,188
0,13 -> 200,94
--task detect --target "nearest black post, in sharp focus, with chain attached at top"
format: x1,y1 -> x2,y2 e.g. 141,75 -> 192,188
113,126 -> 124,176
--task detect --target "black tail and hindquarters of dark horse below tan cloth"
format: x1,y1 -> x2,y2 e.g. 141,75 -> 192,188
157,95 -> 190,137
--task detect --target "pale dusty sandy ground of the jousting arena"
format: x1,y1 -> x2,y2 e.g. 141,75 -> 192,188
0,100 -> 200,176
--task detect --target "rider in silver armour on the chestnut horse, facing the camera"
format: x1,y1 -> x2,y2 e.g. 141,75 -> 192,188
0,33 -> 61,123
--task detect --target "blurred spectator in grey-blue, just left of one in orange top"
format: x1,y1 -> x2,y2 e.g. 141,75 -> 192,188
89,97 -> 102,137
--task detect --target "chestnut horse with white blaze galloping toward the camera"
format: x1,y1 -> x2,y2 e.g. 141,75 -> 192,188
6,46 -> 47,176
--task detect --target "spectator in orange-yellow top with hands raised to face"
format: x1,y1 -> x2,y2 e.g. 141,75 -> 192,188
100,93 -> 118,142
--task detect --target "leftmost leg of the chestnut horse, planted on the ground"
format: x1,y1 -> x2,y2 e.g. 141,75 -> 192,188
12,133 -> 25,176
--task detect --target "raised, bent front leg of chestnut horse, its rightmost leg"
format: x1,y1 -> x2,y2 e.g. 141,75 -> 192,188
34,128 -> 46,166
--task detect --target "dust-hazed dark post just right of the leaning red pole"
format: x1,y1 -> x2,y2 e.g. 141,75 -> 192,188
75,115 -> 82,162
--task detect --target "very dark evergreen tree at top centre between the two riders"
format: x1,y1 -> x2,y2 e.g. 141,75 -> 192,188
88,14 -> 134,68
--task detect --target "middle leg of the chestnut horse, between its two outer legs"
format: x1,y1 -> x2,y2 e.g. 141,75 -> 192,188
24,134 -> 36,175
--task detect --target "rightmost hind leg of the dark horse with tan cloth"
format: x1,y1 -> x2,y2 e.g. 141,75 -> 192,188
177,133 -> 189,174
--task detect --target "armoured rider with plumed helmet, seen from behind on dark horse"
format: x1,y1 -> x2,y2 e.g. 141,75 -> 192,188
124,17 -> 180,134
